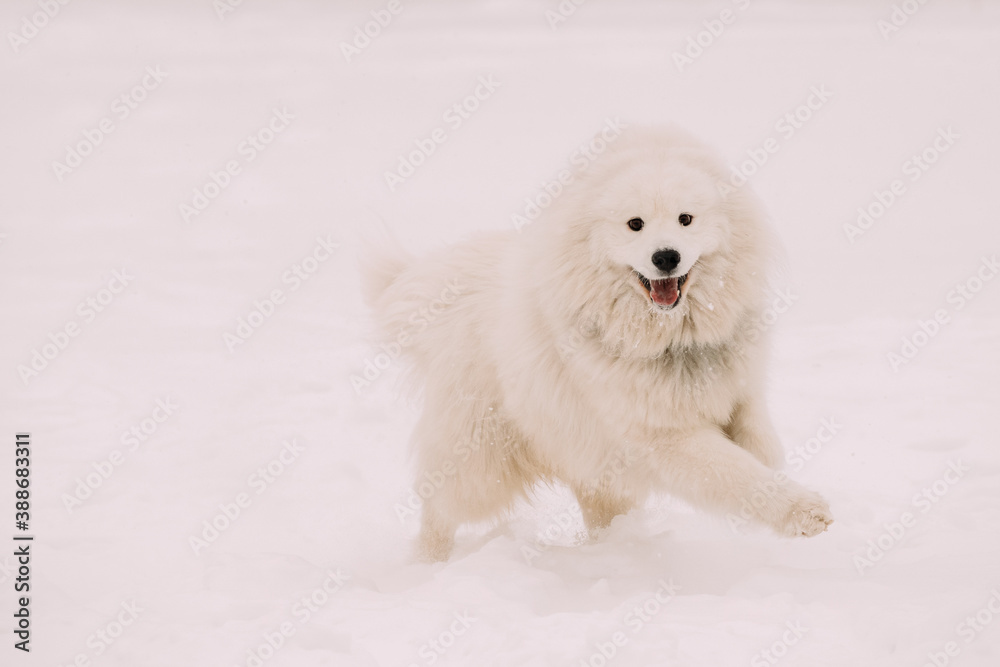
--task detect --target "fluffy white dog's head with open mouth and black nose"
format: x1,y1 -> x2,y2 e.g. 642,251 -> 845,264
547,122 -> 770,357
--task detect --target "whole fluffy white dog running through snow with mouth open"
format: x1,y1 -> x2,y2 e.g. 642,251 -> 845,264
365,124 -> 832,560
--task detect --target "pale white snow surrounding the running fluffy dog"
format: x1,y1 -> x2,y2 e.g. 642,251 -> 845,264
0,0 -> 1000,667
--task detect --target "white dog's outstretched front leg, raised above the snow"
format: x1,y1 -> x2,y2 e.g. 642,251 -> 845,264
658,428 -> 833,537
